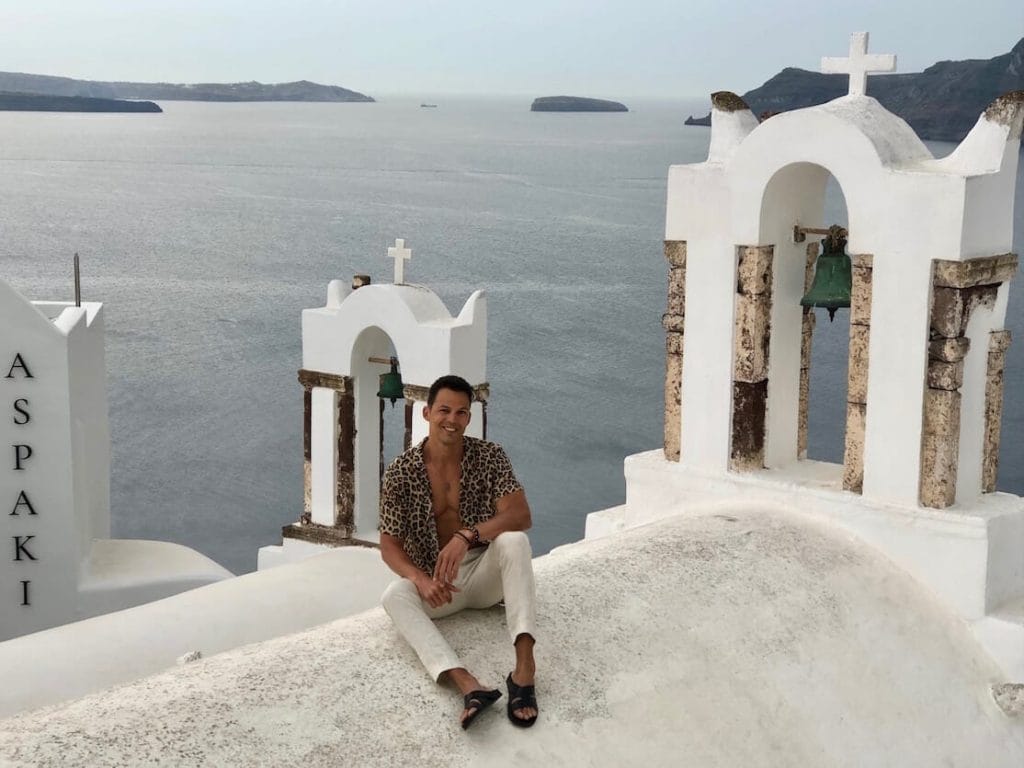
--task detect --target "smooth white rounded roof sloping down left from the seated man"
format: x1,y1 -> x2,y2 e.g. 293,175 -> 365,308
0,543 -> 394,720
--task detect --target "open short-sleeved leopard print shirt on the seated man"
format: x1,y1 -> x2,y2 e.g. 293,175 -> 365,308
379,436 -> 522,573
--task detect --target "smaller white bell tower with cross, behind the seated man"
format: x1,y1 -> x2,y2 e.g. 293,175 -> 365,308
259,239 -> 489,569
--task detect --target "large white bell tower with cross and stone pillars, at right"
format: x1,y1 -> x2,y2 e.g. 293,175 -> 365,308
588,34 -> 1024,679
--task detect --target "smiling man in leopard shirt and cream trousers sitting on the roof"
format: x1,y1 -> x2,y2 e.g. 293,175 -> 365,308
380,376 -> 538,728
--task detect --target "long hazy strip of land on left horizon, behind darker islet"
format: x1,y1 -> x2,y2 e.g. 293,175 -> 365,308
0,72 -> 374,101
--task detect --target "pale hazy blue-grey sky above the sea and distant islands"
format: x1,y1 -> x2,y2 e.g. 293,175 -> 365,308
0,0 -> 1024,98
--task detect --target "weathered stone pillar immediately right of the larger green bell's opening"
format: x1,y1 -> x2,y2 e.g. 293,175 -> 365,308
843,254 -> 874,494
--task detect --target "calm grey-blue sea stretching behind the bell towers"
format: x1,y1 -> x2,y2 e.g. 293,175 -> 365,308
0,96 -> 1024,573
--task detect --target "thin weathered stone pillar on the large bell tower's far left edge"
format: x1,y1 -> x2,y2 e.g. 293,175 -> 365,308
662,240 -> 686,462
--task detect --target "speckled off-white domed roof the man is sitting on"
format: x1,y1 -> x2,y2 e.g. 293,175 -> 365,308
0,510 -> 1024,768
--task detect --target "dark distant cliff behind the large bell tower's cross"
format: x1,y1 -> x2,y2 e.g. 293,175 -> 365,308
686,38 -> 1024,141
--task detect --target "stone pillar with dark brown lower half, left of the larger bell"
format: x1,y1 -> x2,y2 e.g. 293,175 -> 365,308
730,246 -> 775,471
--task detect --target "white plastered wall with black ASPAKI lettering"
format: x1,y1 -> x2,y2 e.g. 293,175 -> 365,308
0,281 -> 110,640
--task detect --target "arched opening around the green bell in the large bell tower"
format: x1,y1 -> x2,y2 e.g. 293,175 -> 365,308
761,163 -> 850,475
